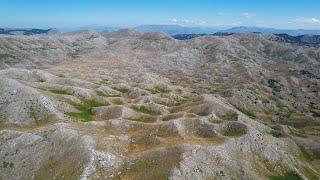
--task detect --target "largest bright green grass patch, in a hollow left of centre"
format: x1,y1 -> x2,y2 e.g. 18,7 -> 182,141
66,100 -> 103,122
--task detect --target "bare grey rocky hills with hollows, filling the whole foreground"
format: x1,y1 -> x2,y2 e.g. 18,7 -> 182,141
0,29 -> 320,179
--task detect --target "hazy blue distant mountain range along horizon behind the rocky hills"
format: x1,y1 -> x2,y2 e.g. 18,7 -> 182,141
0,25 -> 320,36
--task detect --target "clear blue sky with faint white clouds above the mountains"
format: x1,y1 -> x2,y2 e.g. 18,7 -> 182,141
0,0 -> 320,29
